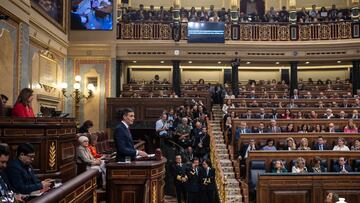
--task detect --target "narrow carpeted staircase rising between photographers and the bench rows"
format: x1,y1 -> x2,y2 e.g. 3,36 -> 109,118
209,105 -> 243,203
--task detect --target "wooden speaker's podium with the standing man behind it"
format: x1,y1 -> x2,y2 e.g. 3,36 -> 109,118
106,152 -> 167,203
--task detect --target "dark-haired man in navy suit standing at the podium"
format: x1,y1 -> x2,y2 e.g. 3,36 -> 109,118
114,108 -> 148,162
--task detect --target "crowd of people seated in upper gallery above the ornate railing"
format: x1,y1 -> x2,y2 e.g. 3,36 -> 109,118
122,4 -> 351,23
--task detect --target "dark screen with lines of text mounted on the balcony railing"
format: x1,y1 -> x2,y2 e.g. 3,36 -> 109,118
188,22 -> 225,43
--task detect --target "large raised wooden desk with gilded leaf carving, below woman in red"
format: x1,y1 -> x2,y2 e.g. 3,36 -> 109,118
0,117 -> 77,182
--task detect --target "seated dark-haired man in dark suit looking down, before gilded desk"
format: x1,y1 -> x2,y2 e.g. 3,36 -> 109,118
5,143 -> 51,194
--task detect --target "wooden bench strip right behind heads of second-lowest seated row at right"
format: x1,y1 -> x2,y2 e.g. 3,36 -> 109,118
237,133 -> 360,151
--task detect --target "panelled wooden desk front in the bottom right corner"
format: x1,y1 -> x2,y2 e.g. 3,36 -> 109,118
256,173 -> 360,203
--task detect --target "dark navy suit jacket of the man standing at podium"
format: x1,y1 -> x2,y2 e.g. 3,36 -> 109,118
114,122 -> 136,161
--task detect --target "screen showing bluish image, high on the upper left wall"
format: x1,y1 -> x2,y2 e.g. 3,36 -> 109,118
70,0 -> 114,30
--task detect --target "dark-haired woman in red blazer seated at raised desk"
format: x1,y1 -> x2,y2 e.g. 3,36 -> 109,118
11,88 -> 35,118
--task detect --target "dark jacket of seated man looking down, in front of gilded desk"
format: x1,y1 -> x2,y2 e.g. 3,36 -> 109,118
5,159 -> 42,194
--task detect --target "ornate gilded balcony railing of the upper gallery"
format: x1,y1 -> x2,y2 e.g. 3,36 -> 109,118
117,22 -> 352,41
